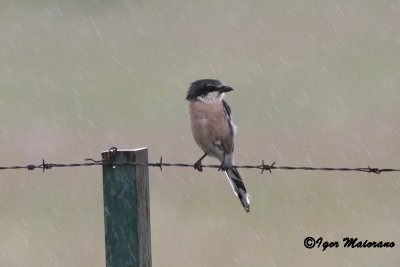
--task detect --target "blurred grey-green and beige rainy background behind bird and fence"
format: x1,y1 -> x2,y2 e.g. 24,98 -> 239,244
0,0 -> 400,266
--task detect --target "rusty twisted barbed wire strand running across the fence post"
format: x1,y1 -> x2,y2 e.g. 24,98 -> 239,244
0,147 -> 400,174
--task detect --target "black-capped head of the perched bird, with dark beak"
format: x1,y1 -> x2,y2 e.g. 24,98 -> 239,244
186,79 -> 233,101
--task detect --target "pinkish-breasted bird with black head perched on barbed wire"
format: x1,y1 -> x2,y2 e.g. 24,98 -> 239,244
186,79 -> 250,212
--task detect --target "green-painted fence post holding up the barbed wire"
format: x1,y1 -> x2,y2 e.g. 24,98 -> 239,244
101,148 -> 151,267
